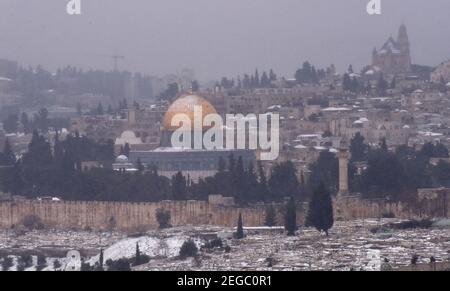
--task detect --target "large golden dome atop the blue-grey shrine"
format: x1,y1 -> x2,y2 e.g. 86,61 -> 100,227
163,94 -> 217,131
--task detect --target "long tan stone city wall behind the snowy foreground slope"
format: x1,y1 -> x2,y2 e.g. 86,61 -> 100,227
0,197 -> 450,231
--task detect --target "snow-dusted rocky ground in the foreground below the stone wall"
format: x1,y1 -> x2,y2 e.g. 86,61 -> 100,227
0,219 -> 450,271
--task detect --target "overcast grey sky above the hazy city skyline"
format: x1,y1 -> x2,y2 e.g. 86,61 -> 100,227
0,0 -> 450,80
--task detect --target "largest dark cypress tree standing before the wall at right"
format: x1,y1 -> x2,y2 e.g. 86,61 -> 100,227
306,183 -> 334,236
